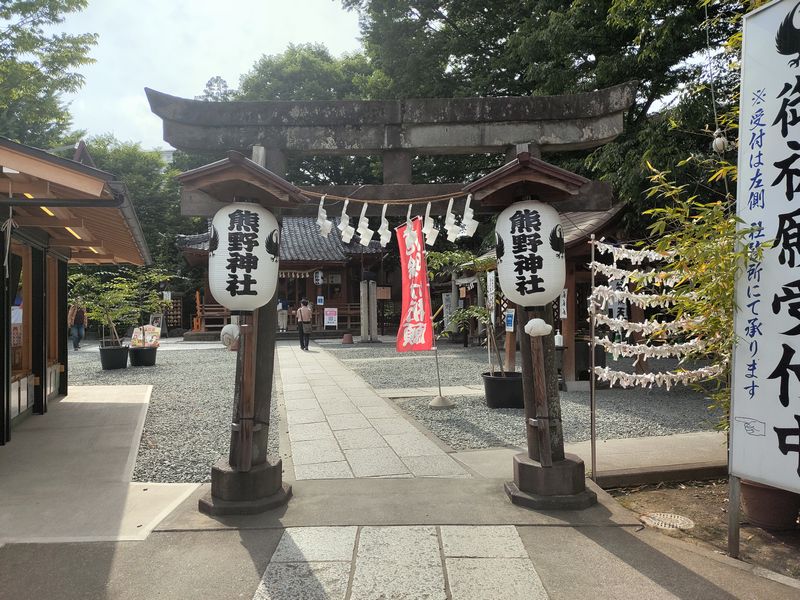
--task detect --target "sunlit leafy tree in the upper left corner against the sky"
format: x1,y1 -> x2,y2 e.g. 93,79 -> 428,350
0,0 -> 97,148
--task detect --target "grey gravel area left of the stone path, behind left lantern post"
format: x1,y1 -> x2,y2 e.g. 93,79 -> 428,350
69,347 -> 278,483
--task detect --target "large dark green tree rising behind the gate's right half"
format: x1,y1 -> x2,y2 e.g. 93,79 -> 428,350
343,0 -> 744,234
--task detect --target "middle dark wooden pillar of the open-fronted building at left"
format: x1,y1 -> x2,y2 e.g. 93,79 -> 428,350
30,248 -> 48,415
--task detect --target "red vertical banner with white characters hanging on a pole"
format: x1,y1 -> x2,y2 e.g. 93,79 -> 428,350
395,217 -> 433,352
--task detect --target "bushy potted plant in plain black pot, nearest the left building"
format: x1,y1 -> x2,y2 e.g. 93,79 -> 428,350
70,272 -> 137,370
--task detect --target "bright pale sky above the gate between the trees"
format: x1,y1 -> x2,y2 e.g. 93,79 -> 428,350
57,0 -> 360,149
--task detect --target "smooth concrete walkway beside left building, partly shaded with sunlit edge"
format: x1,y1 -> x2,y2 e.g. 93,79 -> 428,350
0,385 -> 198,544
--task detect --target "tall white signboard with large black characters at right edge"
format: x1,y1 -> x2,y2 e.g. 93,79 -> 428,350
730,0 -> 800,492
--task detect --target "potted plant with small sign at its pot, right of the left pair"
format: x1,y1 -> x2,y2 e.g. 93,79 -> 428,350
127,269 -> 171,367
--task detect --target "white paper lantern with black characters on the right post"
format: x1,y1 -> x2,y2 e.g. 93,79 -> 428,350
495,200 -> 566,307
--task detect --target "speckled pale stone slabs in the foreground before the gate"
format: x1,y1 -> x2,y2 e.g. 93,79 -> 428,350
254,525 -> 548,600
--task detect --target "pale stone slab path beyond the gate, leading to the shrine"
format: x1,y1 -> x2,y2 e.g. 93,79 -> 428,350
277,342 -> 469,479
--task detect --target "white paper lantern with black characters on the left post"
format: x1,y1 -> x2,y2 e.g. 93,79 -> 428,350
208,202 -> 280,310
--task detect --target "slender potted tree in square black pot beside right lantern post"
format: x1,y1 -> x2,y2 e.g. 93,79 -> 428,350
450,306 -> 525,408
